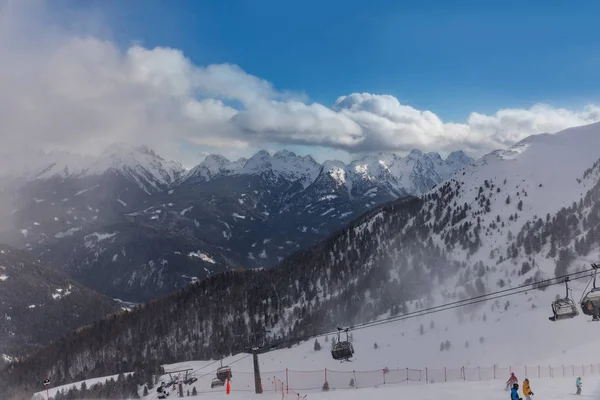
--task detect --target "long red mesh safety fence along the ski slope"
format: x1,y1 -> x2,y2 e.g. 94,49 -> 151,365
194,363 -> 600,394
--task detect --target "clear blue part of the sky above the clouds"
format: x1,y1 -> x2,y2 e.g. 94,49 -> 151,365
59,0 -> 600,121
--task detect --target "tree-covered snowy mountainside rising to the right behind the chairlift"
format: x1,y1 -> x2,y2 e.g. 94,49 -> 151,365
7,124 -> 600,398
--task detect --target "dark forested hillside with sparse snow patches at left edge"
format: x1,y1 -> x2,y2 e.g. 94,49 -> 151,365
0,245 -> 121,364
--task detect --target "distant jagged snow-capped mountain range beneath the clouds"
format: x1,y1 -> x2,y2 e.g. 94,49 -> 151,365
0,144 -> 473,301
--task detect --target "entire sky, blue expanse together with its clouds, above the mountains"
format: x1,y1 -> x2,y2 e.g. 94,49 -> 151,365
0,0 -> 600,164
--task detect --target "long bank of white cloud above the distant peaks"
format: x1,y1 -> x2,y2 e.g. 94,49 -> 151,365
0,0 -> 600,166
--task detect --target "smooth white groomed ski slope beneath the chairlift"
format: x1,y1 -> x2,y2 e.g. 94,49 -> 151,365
37,281 -> 600,400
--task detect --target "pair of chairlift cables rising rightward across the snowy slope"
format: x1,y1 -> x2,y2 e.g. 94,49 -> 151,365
286,268 -> 594,341
